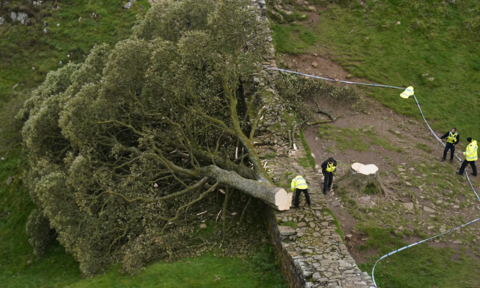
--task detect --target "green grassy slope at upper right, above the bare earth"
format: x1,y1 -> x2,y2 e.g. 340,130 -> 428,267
273,0 -> 480,140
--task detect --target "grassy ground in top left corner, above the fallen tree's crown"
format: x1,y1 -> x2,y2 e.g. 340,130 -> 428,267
0,0 -> 150,102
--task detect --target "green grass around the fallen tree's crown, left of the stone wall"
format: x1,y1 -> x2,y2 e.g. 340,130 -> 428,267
0,0 -> 284,287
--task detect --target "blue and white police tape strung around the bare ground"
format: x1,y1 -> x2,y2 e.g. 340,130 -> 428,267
265,66 -> 480,287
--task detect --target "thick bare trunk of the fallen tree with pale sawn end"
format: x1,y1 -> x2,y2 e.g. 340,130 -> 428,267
200,165 -> 293,211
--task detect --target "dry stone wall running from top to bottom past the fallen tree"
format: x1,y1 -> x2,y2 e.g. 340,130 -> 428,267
252,0 -> 374,288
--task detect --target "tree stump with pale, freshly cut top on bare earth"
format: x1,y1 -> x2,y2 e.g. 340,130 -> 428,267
336,163 -> 392,197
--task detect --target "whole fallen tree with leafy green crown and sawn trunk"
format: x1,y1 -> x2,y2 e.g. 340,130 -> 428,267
17,0 -> 292,276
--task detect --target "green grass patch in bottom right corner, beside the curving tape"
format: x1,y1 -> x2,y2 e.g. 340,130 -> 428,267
359,227 -> 480,288
